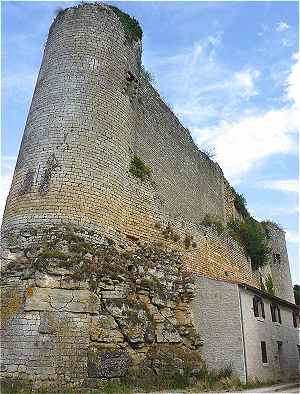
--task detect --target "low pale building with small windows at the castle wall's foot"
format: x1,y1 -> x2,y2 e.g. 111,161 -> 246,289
193,277 -> 300,383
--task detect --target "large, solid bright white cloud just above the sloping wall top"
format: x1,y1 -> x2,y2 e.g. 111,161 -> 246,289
192,109 -> 300,181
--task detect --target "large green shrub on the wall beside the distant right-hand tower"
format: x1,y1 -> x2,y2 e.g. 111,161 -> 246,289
228,217 -> 271,269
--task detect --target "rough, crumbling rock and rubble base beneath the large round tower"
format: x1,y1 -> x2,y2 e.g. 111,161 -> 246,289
1,227 -> 201,387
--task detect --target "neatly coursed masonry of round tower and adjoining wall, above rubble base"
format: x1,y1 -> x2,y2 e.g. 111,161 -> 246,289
2,5 -> 255,290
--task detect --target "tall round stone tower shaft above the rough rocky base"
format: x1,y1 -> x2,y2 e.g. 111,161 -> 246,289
2,5 -> 141,239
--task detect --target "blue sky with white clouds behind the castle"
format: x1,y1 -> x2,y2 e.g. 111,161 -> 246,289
0,2 -> 300,283
